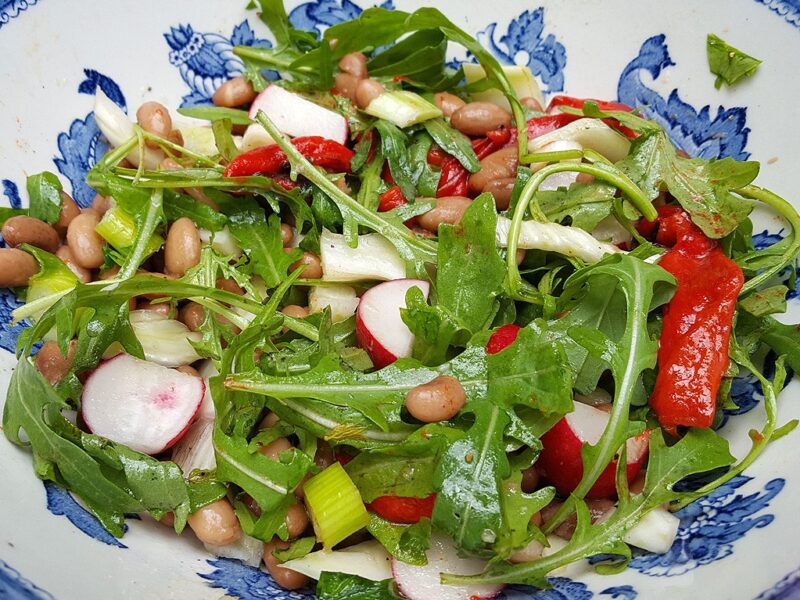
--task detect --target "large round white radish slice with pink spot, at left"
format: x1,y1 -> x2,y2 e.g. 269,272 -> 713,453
81,354 -> 205,454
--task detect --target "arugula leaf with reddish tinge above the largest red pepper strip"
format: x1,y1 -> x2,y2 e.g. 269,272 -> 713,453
617,130 -> 758,239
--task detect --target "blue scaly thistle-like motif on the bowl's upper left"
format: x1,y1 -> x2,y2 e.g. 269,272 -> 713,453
164,21 -> 272,107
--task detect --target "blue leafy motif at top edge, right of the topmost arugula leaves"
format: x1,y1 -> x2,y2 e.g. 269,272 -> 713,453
476,7 -> 567,93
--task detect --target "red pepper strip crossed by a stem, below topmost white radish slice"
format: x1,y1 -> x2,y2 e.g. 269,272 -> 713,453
224,135 -> 353,177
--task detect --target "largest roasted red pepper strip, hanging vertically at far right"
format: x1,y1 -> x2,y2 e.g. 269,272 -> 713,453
640,206 -> 744,435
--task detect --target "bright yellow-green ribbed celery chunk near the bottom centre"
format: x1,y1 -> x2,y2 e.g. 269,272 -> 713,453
303,462 -> 369,550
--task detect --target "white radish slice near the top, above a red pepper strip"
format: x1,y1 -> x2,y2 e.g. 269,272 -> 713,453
250,84 -> 348,144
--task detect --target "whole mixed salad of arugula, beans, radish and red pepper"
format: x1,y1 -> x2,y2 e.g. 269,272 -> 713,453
0,0 -> 800,600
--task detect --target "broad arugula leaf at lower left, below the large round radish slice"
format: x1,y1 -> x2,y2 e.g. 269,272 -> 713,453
3,358 -> 189,537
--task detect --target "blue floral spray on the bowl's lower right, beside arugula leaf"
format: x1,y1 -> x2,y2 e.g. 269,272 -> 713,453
629,475 -> 785,577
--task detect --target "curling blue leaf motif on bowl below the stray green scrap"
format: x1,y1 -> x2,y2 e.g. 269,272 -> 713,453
617,34 -> 750,160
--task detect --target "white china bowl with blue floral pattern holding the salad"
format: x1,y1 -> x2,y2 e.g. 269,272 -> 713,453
0,0 -> 800,600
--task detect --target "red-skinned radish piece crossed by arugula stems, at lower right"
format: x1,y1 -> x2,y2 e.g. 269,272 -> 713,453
536,402 -> 650,498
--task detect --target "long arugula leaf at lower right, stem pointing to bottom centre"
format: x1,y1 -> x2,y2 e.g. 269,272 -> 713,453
442,429 -> 734,587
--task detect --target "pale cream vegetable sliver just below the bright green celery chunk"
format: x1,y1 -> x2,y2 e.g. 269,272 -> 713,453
281,540 -> 392,581
